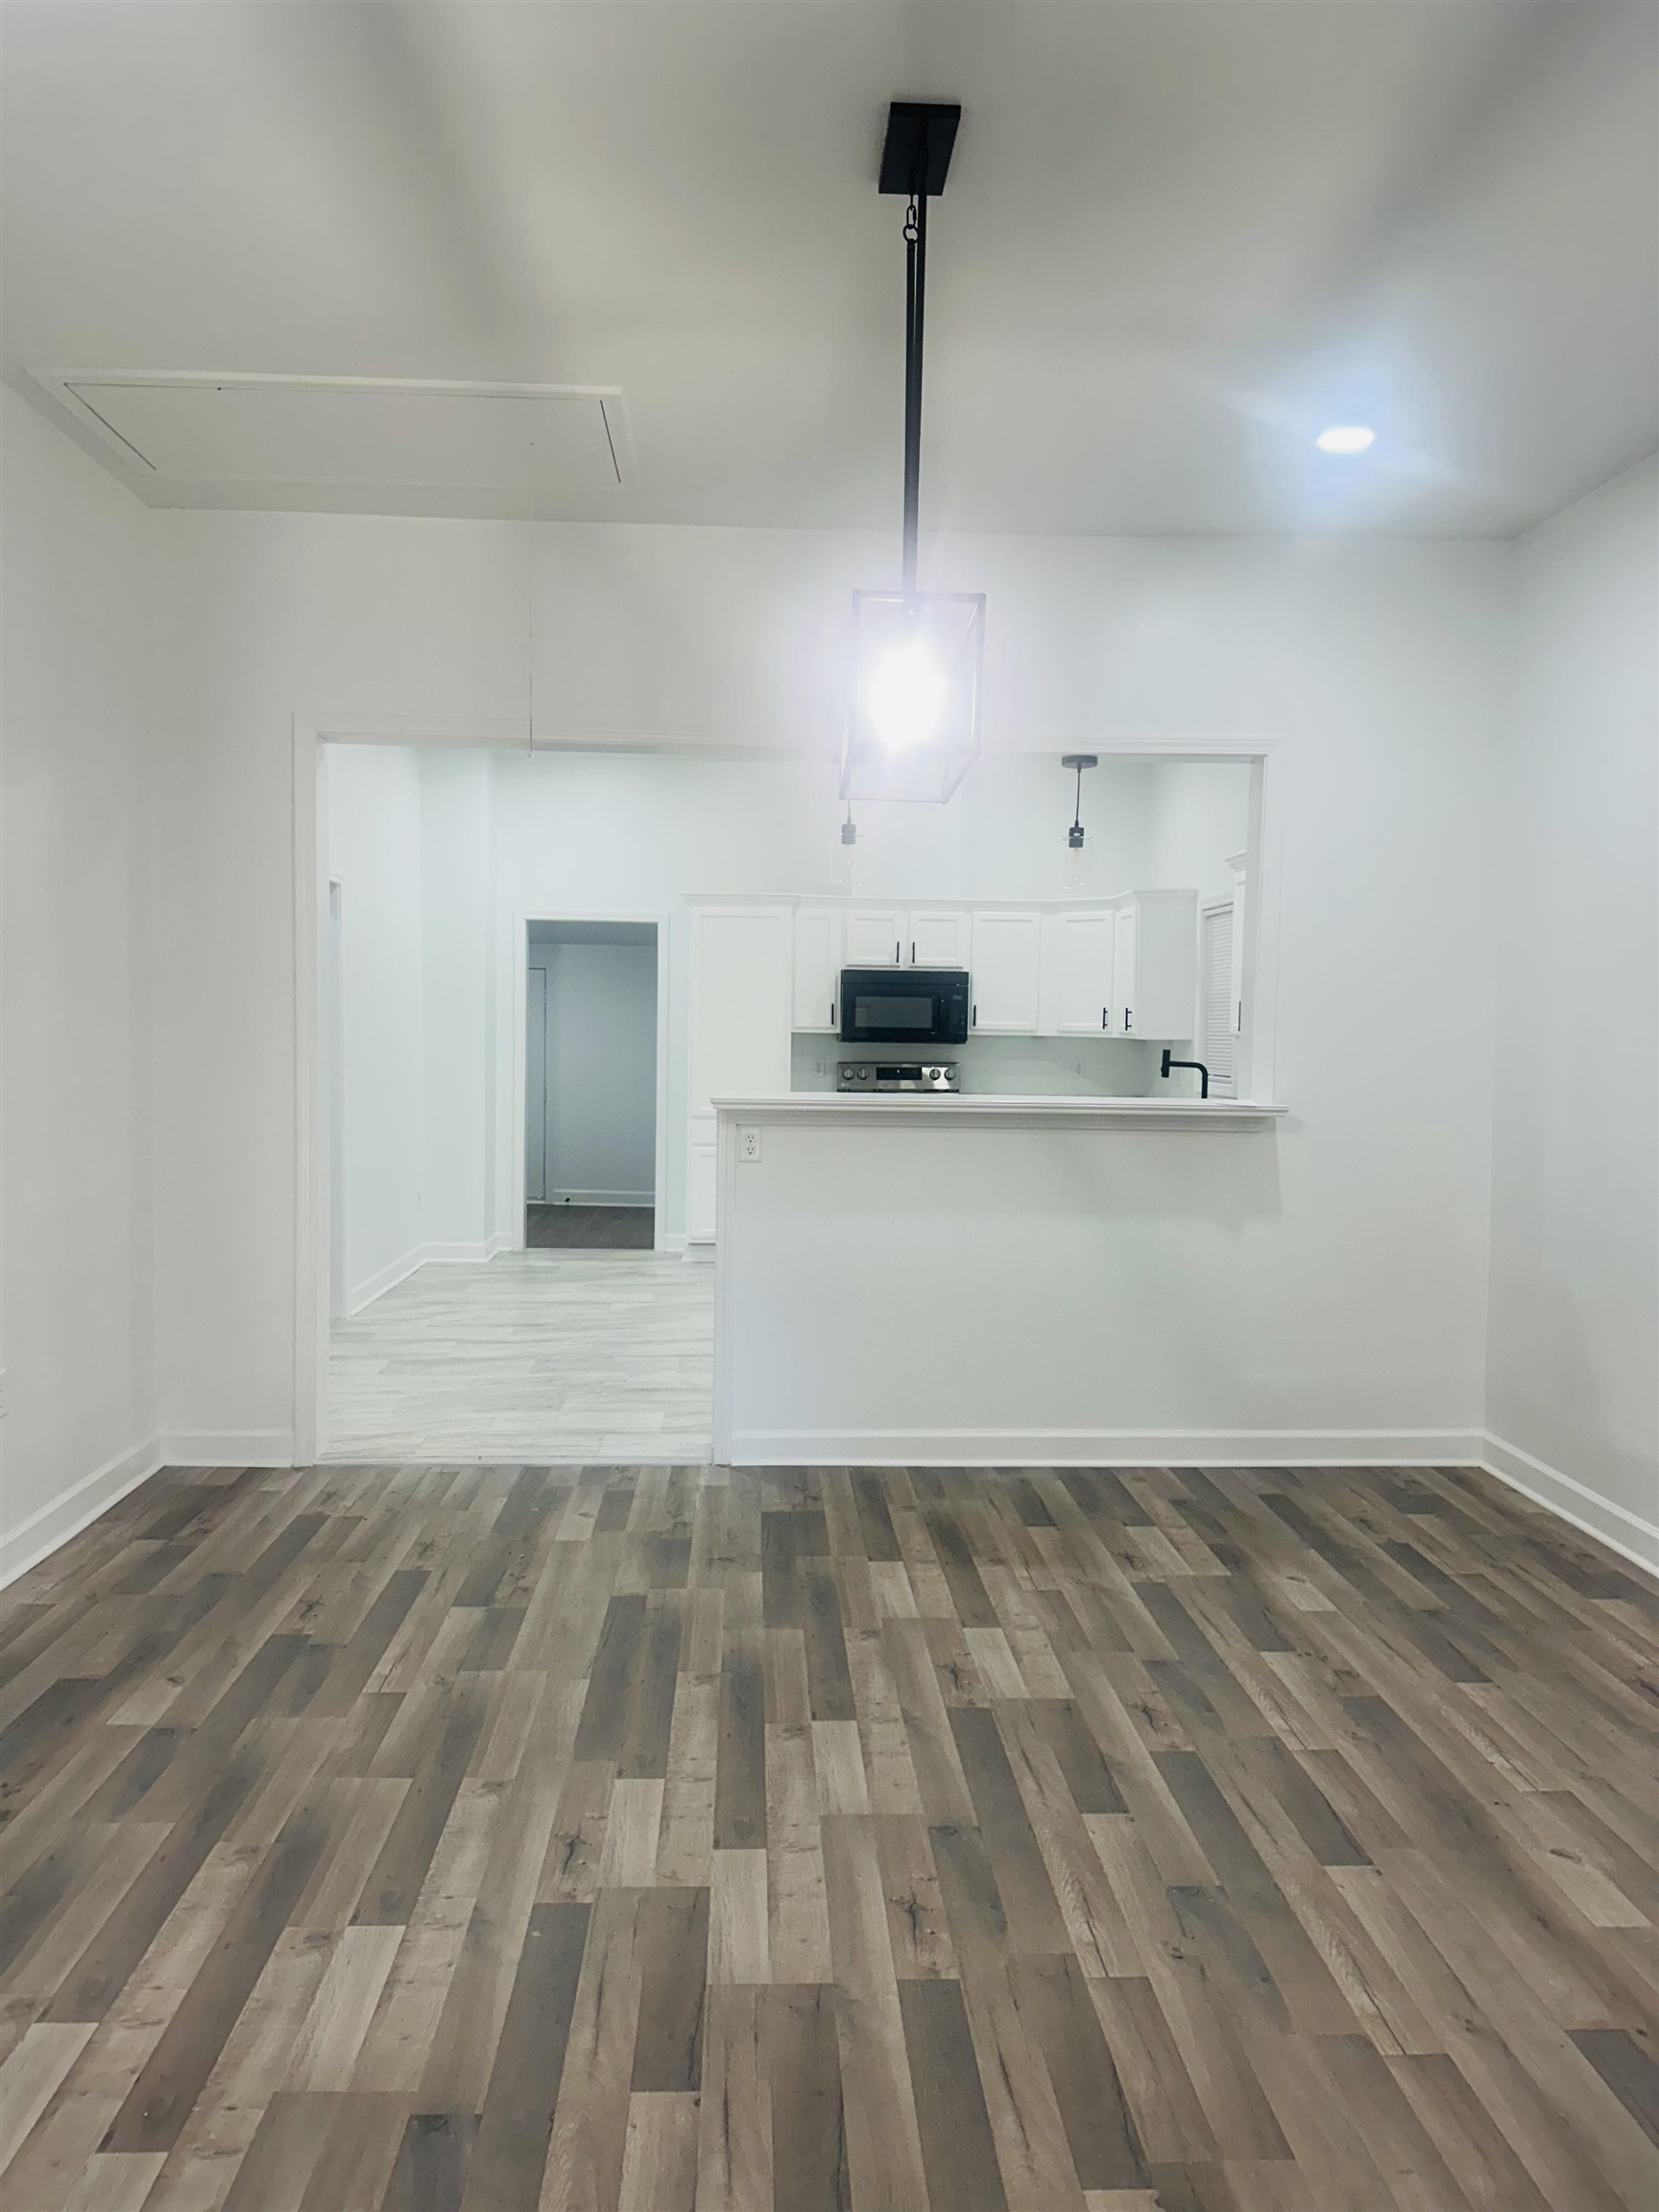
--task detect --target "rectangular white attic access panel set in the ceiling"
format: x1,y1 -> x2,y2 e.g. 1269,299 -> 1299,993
36,372 -> 631,497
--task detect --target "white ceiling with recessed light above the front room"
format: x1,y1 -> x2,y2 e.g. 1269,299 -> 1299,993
2,0 -> 1659,533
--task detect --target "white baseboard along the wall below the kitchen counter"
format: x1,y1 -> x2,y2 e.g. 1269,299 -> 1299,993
721,1432 -> 1484,1467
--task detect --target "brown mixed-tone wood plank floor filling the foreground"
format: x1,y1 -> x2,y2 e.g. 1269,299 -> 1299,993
0,1467 -> 1659,2212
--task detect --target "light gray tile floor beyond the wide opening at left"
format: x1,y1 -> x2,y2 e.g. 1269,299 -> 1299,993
327,1252 -> 714,1462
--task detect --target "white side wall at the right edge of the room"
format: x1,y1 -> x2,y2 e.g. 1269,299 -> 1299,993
1486,463 -> 1659,1544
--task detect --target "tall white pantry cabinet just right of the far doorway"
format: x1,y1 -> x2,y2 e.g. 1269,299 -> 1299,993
685,902 -> 794,1243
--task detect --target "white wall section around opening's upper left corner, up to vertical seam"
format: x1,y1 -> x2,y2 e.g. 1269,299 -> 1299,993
146,511 -> 526,1462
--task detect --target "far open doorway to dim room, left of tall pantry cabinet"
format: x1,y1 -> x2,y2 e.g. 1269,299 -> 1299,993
524,920 -> 657,1252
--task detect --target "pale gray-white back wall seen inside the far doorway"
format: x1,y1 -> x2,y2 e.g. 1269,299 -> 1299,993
531,945 -> 657,1206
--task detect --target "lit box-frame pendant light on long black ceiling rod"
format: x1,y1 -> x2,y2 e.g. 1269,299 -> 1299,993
841,100 -> 984,801
